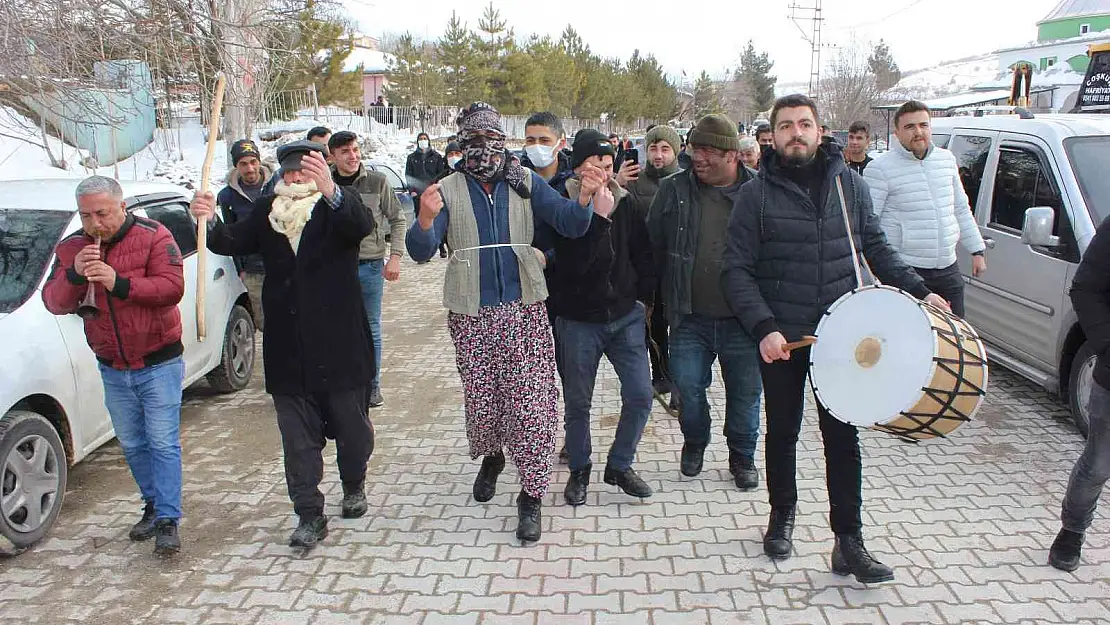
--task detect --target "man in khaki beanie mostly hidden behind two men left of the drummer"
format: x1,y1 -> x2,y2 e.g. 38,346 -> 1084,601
625,125 -> 683,412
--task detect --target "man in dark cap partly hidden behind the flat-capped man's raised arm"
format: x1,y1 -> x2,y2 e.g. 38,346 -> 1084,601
215,139 -> 273,330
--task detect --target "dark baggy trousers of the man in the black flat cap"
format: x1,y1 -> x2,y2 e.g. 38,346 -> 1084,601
273,389 -> 374,517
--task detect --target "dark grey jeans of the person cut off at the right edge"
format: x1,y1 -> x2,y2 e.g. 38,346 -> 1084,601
1060,382 -> 1110,534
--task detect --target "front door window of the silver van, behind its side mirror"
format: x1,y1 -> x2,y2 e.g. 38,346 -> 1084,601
990,145 -> 1072,258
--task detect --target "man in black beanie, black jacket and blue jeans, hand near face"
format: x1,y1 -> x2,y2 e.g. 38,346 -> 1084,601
547,129 -> 655,505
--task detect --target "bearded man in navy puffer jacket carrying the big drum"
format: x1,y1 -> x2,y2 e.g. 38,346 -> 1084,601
722,95 -> 948,583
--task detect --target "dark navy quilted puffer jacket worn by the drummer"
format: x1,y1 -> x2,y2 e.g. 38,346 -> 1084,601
720,143 -> 929,341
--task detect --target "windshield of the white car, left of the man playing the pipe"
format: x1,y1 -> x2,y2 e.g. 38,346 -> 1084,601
0,209 -> 73,313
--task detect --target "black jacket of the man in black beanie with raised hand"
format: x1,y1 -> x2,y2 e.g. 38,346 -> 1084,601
547,183 -> 656,323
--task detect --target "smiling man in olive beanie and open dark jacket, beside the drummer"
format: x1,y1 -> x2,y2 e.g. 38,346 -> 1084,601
647,114 -> 763,490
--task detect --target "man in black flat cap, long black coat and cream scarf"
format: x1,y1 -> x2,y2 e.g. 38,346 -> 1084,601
190,141 -> 375,548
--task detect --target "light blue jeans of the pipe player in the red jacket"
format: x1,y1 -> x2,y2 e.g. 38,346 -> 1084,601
100,356 -> 185,521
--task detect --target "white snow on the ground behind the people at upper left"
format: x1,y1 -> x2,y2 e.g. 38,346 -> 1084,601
0,107 -> 415,192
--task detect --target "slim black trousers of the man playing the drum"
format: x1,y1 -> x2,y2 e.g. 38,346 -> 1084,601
759,349 -> 864,534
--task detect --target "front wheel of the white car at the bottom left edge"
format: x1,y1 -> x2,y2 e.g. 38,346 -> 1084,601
0,410 -> 69,555
